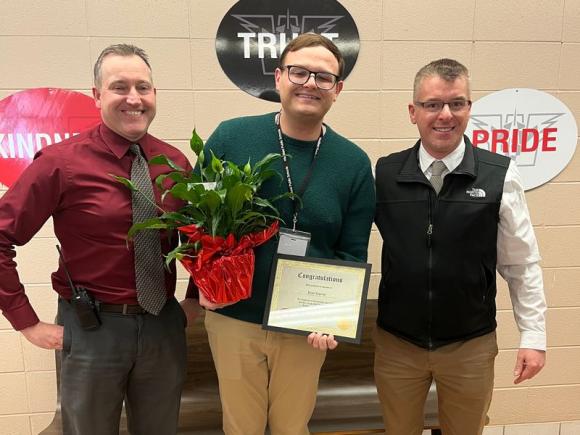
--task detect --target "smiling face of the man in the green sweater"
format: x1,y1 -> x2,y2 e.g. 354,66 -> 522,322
275,46 -> 342,122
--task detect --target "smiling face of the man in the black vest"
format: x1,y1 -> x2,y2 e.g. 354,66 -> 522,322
409,75 -> 471,159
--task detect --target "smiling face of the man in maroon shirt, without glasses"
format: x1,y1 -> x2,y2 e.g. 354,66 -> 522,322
93,55 -> 156,142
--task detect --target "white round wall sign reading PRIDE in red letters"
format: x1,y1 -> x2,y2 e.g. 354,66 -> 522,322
465,88 -> 578,190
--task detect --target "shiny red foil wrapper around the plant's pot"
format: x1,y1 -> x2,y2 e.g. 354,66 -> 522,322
178,221 -> 279,304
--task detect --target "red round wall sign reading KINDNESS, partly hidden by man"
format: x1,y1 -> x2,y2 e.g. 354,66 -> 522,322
0,88 -> 101,187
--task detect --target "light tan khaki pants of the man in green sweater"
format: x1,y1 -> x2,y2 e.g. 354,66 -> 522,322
205,311 -> 326,435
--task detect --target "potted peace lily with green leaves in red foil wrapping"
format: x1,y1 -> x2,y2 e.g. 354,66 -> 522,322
114,129 -> 292,303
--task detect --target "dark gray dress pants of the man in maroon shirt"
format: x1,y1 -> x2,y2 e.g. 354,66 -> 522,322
58,299 -> 187,435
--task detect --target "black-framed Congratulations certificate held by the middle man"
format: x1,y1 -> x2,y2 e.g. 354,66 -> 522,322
262,254 -> 371,344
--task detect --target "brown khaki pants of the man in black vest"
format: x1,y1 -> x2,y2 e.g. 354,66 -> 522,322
374,327 -> 497,435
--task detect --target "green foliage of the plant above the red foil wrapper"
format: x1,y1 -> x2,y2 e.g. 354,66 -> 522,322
114,142 -> 292,249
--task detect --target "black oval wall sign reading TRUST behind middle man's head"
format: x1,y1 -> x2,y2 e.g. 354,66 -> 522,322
215,0 -> 360,102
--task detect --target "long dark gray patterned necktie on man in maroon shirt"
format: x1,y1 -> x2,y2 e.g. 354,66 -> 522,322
130,144 -> 167,315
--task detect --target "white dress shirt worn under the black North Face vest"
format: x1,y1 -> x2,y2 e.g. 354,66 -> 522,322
419,140 -> 546,350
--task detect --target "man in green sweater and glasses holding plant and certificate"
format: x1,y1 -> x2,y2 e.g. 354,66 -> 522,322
188,34 -> 375,435
